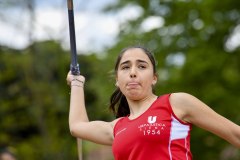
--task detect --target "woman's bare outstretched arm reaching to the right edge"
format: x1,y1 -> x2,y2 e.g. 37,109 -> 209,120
170,93 -> 240,148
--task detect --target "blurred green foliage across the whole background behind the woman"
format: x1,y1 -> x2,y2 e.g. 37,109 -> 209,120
0,0 -> 240,160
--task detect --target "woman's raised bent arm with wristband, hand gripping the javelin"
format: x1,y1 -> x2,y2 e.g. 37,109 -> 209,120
67,72 -> 116,145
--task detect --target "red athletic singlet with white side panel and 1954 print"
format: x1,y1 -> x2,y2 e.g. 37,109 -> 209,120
112,94 -> 192,160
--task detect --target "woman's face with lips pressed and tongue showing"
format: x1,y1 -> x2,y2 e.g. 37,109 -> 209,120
116,48 -> 157,100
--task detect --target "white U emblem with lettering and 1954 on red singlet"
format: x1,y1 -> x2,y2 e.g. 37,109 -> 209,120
138,116 -> 166,136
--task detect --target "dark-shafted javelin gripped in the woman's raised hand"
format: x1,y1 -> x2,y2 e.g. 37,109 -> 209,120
67,0 -> 82,160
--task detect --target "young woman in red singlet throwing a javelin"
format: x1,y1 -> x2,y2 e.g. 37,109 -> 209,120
67,46 -> 240,160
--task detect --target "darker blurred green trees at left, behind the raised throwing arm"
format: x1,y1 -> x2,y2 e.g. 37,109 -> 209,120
0,41 -> 115,160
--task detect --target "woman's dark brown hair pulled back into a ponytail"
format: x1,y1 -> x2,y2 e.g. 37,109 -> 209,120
109,46 -> 156,118
